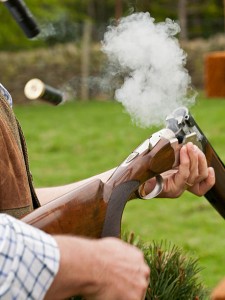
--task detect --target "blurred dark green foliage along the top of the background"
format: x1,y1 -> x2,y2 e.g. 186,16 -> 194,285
0,0 -> 224,50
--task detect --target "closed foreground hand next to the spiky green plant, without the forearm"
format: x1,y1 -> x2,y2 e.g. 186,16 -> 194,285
87,238 -> 150,300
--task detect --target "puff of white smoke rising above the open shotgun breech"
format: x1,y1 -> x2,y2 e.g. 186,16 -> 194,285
102,13 -> 195,127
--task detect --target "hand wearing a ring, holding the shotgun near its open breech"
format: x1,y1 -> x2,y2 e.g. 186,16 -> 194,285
145,142 -> 215,198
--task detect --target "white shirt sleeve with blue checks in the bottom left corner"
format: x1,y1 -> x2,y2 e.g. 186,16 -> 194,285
0,214 -> 60,300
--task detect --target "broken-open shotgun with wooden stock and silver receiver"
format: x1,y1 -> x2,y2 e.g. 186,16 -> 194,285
22,107 -> 225,238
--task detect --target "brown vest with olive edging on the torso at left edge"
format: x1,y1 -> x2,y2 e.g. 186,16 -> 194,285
0,93 -> 40,218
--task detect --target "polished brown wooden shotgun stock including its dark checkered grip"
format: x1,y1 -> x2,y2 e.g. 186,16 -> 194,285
22,139 -> 175,238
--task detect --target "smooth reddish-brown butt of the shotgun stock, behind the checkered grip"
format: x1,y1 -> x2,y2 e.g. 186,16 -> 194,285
22,179 -> 107,238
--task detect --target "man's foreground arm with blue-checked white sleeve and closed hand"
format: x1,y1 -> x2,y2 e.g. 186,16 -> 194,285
0,214 -> 150,300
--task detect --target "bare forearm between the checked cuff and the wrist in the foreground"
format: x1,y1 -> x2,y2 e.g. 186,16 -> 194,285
45,236 -> 100,300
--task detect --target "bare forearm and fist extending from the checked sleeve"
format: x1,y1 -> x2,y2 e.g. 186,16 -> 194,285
45,236 -> 150,300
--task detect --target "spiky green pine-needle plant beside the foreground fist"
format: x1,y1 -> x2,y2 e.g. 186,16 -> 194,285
123,233 -> 208,300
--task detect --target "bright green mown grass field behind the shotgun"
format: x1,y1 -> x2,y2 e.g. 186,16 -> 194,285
15,96 -> 225,288
